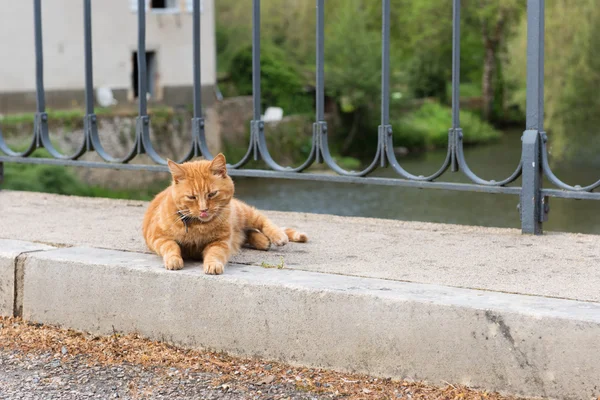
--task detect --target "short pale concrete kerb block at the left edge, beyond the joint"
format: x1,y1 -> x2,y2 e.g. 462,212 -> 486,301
0,239 -> 53,317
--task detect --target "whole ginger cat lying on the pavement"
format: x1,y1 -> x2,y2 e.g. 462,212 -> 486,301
143,154 -> 308,275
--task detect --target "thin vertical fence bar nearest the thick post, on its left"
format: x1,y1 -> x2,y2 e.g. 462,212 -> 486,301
448,0 -> 462,172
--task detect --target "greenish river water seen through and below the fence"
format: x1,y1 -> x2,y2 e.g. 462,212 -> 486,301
236,131 -> 600,234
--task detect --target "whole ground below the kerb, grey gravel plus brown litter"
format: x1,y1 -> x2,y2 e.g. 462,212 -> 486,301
0,317 -> 516,400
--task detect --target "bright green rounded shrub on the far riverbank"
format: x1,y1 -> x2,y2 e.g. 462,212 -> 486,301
392,103 -> 500,148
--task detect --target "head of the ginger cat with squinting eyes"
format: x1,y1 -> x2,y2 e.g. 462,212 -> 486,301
168,154 -> 234,222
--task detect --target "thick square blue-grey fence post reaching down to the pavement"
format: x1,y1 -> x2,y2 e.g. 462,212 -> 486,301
520,0 -> 544,235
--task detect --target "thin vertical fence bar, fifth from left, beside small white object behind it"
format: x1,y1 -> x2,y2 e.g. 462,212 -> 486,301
250,0 -> 264,161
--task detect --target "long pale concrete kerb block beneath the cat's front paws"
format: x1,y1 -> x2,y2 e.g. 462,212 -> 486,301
23,247 -> 600,399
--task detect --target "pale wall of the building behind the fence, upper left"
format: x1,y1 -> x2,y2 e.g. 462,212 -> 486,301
0,0 -> 216,112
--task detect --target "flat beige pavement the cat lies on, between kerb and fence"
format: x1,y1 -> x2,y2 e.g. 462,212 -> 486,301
0,191 -> 600,301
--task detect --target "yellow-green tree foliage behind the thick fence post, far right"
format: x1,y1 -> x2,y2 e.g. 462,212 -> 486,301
507,0 -> 600,159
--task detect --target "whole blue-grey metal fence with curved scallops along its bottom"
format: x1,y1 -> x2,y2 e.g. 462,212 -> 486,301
0,0 -> 600,234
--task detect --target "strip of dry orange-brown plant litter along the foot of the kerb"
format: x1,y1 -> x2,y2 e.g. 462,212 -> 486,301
0,318 -> 528,400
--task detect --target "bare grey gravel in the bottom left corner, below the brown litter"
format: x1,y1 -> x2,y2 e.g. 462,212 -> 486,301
0,351 -> 330,400
